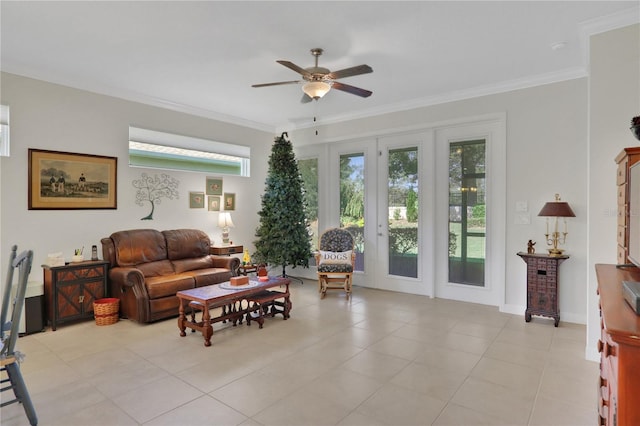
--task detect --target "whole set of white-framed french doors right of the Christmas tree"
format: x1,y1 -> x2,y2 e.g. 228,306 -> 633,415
303,114 -> 506,306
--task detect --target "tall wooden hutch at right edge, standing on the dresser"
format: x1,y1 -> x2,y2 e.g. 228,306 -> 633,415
616,147 -> 640,265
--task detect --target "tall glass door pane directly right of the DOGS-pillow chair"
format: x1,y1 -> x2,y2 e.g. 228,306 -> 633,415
340,153 -> 364,271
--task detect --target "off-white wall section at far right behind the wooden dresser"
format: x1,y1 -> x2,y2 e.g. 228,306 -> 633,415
586,24 -> 640,360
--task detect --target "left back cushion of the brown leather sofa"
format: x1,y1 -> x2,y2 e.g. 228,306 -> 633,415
111,229 -> 167,266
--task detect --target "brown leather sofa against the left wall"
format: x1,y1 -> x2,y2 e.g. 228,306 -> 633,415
101,229 -> 240,323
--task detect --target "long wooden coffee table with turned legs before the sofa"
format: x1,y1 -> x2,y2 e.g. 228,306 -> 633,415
176,277 -> 291,346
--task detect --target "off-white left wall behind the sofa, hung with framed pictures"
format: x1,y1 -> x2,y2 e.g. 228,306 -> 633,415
0,73 -> 274,280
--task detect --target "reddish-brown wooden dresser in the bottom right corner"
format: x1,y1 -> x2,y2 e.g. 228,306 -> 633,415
596,264 -> 640,426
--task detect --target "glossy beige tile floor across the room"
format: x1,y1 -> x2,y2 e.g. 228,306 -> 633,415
0,281 -> 598,426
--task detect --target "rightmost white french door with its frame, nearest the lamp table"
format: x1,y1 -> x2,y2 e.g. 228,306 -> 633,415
435,119 -> 506,306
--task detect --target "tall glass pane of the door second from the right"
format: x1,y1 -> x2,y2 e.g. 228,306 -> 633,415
387,147 -> 419,278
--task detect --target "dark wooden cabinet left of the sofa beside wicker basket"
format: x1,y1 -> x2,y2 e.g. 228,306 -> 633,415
42,260 -> 109,331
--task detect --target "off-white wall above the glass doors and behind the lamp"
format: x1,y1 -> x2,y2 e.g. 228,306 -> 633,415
291,78 -> 587,323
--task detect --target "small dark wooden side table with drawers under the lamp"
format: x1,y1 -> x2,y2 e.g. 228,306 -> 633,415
518,252 -> 569,327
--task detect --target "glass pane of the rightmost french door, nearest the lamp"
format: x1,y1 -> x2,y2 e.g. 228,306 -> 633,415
449,140 -> 486,287
